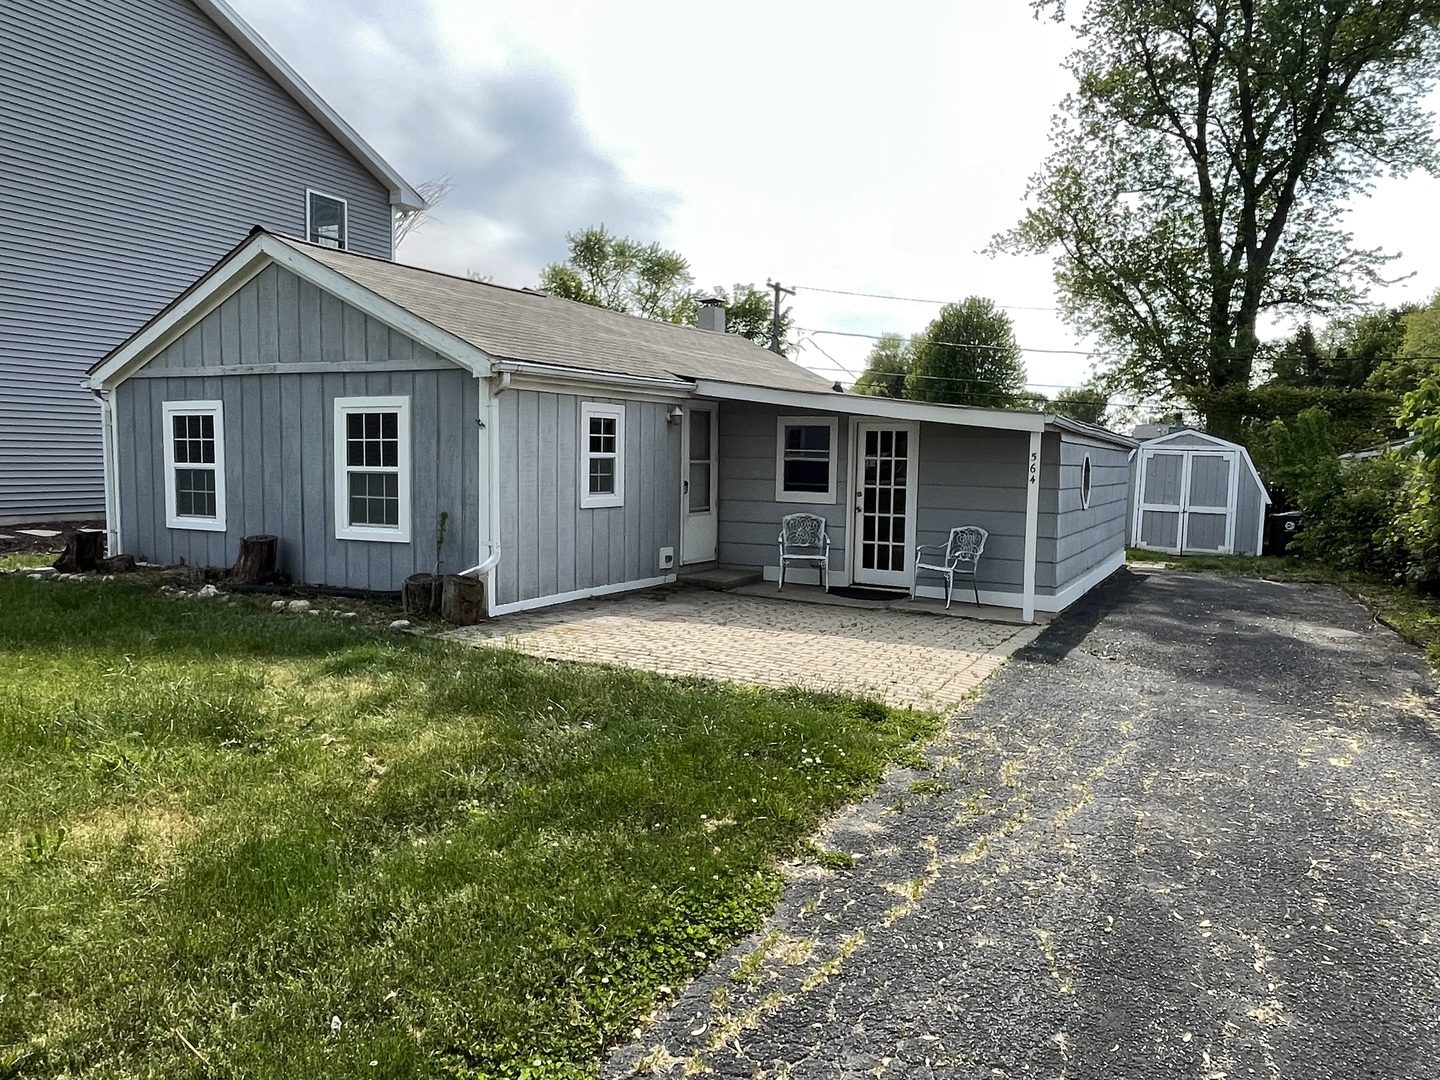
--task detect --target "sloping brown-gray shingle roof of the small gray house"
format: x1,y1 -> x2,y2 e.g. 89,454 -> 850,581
276,236 -> 831,392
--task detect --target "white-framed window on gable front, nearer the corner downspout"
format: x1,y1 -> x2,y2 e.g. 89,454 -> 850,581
336,397 -> 410,544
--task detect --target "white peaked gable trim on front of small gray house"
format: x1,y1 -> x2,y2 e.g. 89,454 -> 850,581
88,233 -> 491,390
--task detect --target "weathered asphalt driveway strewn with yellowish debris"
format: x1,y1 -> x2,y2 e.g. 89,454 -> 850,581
605,572 -> 1440,1080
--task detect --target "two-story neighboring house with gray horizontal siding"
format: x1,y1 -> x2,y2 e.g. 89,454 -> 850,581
0,0 -> 423,524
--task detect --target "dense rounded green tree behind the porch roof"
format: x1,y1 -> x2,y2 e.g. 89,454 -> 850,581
904,297 -> 1025,409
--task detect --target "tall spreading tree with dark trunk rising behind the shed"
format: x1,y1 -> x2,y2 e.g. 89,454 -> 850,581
994,0 -> 1440,433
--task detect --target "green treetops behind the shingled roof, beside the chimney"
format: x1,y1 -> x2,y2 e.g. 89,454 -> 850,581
540,225 -> 795,353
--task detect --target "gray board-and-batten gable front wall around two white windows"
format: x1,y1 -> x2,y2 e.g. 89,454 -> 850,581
114,266 -> 481,592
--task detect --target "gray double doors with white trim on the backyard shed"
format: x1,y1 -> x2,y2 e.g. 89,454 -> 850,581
1136,448 -> 1240,554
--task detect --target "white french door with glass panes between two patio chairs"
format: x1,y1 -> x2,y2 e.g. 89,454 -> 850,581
850,422 -> 920,588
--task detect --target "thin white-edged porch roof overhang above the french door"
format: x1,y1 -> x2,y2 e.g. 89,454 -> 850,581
694,379 -> 1138,448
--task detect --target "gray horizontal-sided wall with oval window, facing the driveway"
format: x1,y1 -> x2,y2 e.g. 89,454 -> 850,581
1037,433 -> 1130,595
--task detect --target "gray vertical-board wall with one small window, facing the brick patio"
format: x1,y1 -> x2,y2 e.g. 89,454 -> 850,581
495,390 -> 681,605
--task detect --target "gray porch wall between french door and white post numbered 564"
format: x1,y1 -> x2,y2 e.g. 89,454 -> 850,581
916,423 -> 1047,593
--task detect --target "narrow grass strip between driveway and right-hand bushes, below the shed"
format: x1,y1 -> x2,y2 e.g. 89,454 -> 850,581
1128,547 -> 1440,668
